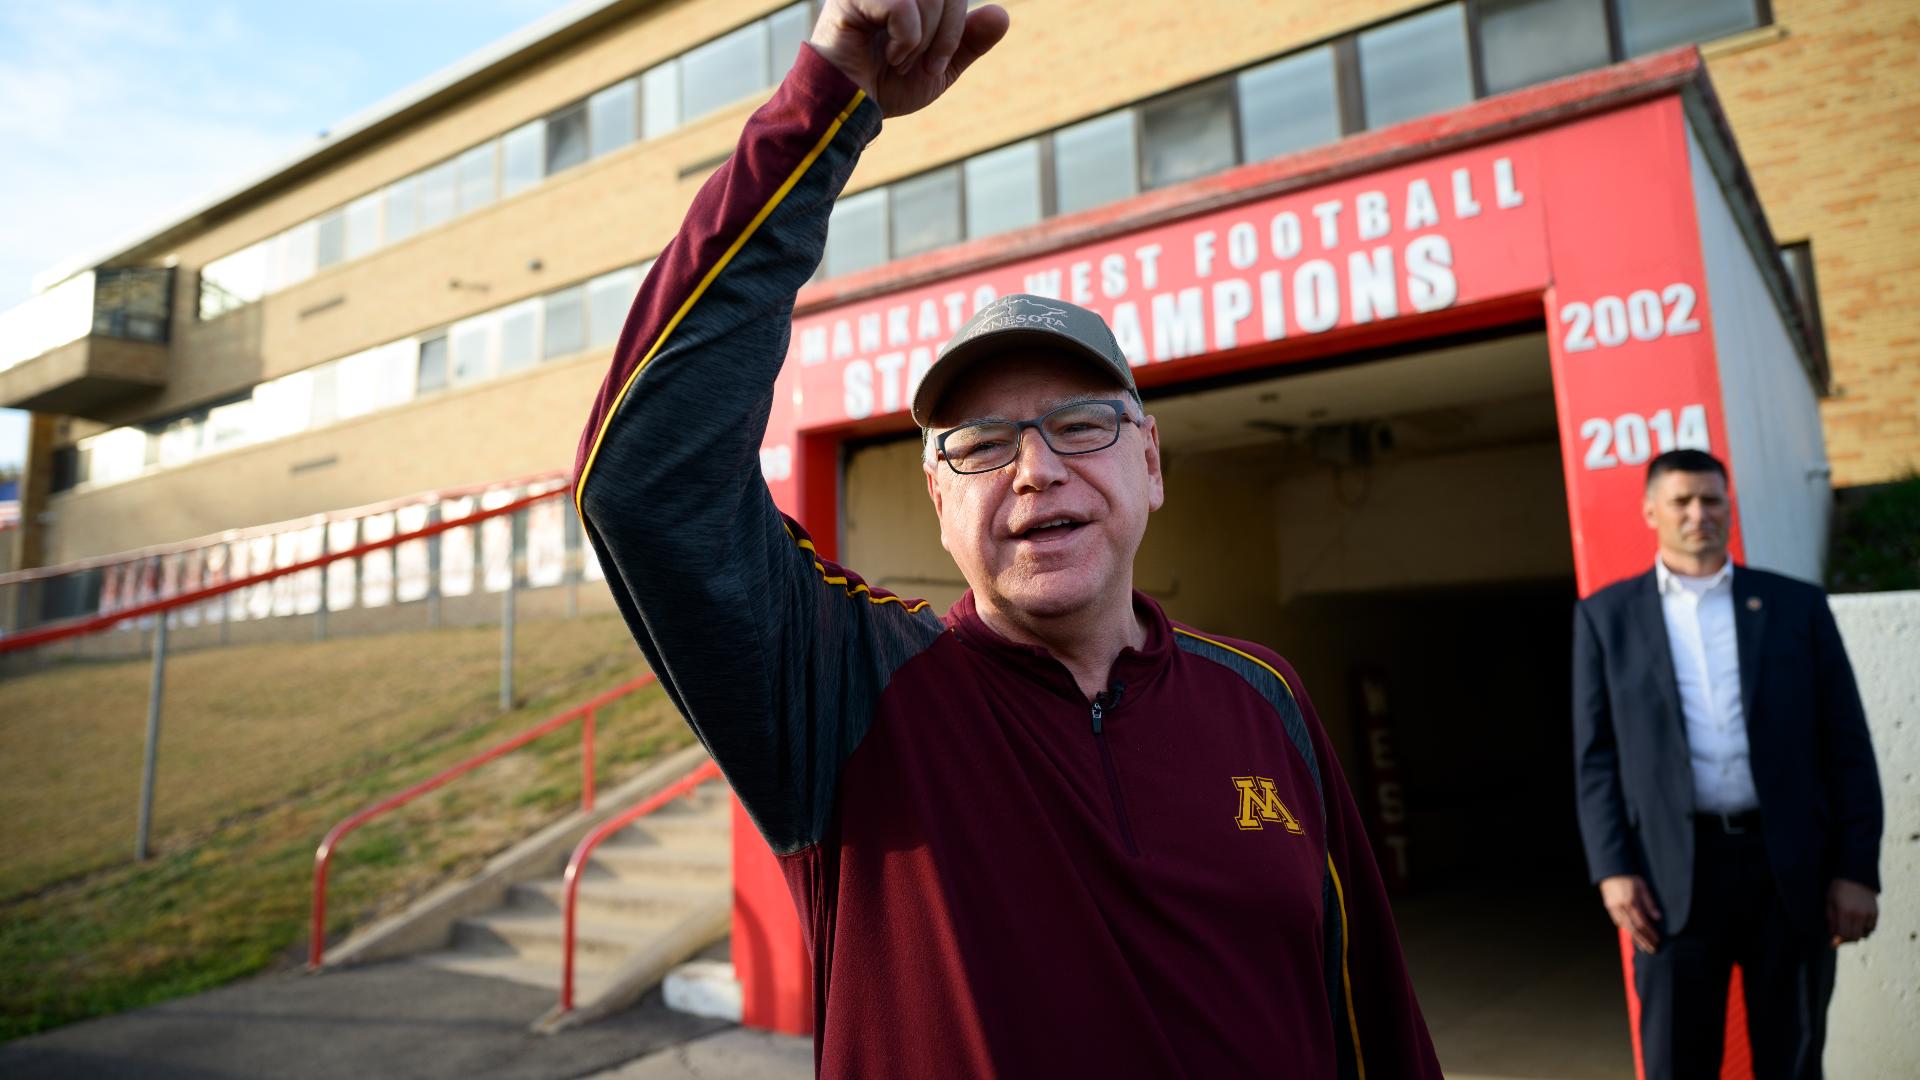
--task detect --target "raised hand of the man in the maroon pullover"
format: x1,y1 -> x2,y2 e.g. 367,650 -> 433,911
808,0 -> 1008,117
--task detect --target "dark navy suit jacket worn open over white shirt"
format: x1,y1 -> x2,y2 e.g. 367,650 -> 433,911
1572,567 -> 1882,938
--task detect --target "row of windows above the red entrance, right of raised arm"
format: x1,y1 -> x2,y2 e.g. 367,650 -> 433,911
820,0 -> 1766,277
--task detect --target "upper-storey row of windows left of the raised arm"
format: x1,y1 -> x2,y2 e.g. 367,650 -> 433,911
200,0 -> 812,319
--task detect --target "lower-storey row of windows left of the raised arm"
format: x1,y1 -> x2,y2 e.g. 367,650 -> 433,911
54,263 -> 651,490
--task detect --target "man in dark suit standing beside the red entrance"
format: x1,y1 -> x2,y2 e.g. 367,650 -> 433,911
1572,450 -> 1882,1080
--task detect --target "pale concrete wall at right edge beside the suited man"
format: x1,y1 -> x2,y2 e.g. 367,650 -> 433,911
1826,592 -> 1920,1080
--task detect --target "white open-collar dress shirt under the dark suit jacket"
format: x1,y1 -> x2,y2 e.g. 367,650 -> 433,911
1653,557 -> 1761,813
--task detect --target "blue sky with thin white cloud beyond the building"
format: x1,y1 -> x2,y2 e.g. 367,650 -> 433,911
0,0 -> 568,469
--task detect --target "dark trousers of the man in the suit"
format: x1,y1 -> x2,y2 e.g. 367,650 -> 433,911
1634,817 -> 1834,1080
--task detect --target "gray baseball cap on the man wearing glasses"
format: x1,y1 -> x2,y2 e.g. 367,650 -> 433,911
912,292 -> 1140,427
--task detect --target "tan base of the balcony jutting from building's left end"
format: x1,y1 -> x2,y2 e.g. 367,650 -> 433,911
0,334 -> 167,421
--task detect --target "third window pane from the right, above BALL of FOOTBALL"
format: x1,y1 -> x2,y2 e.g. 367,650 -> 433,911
1359,4 -> 1473,127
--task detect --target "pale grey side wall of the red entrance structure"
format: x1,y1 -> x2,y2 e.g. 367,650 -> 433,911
1688,133 -> 1834,580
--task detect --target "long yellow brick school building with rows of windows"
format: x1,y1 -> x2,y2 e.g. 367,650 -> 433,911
0,0 -> 1920,563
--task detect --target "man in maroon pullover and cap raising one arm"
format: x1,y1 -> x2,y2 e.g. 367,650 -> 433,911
574,0 -> 1440,1078
